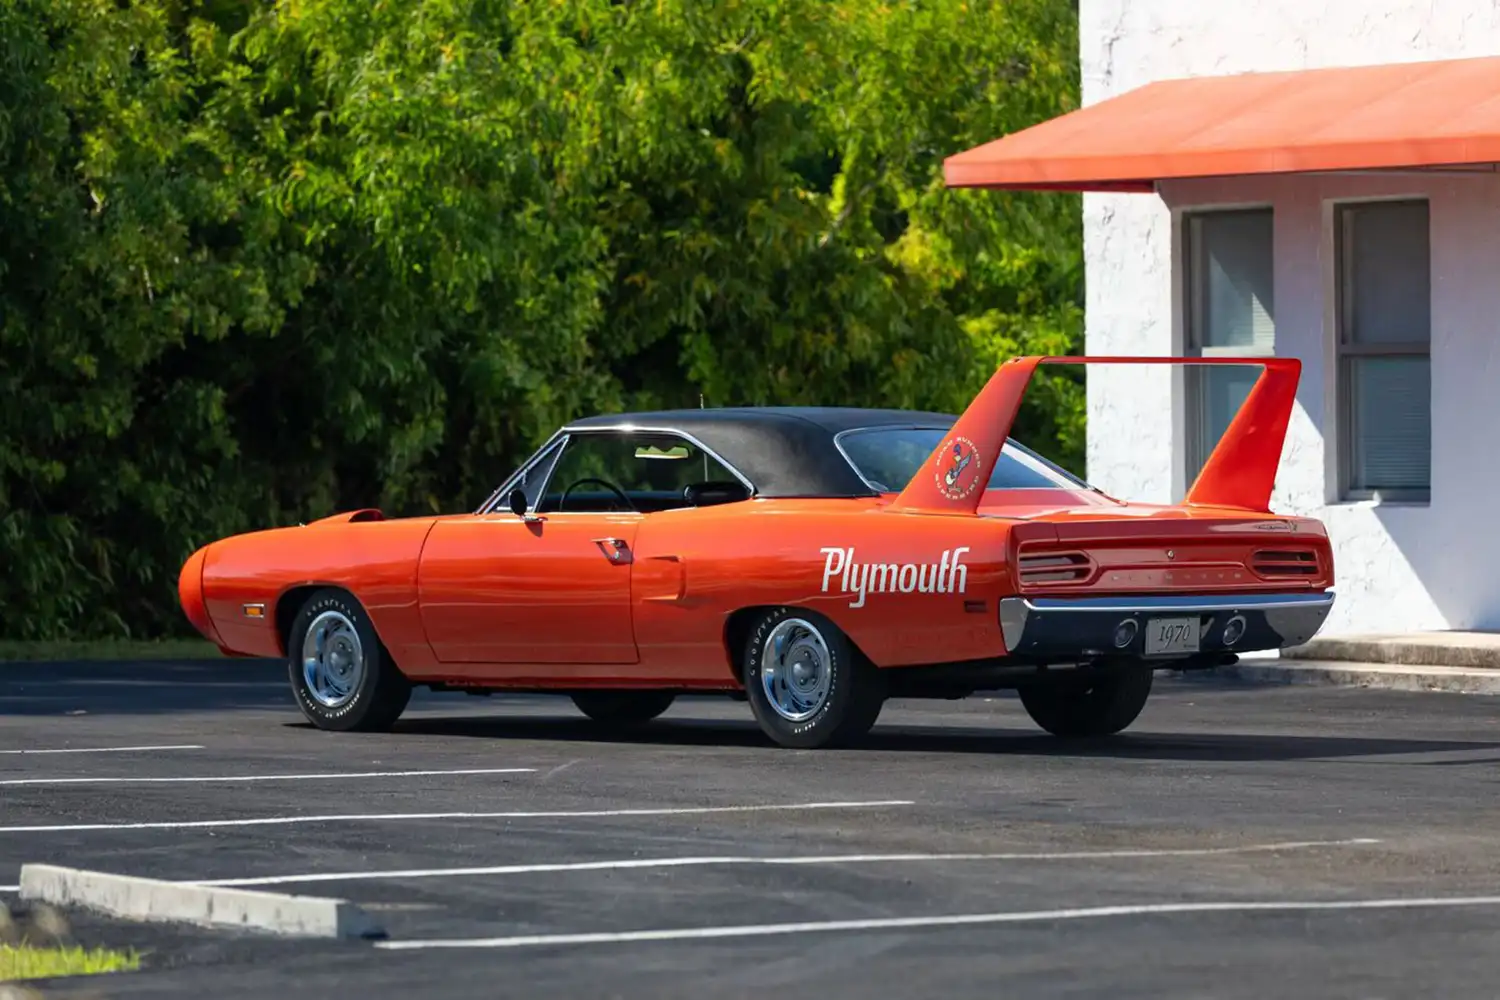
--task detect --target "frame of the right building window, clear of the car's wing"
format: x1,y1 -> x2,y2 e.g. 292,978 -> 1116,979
1334,195 -> 1433,505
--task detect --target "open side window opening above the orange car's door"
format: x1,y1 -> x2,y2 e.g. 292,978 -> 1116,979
539,430 -> 738,513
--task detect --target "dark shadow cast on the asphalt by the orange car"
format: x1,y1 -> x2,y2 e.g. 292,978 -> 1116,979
381,715 -> 1500,763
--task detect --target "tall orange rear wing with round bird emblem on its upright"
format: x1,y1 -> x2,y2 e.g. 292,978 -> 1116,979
893,357 -> 1302,514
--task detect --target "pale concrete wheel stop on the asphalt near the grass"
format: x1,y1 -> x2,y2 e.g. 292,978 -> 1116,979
21,865 -> 386,939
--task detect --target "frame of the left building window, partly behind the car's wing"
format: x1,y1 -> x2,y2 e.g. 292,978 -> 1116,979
1179,202 -> 1277,483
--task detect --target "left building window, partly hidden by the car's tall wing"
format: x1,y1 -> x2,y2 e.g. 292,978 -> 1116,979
1182,208 -> 1277,483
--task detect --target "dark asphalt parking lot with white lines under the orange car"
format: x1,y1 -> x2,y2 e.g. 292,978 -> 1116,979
0,661 -> 1500,1000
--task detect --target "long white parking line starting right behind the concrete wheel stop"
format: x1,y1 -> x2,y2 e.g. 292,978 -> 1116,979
189,837 -> 1380,888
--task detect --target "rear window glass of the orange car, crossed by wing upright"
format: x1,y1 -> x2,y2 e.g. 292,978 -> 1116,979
839,427 -> 1092,493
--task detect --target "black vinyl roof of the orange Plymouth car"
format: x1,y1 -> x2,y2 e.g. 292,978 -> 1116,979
563,406 -> 957,496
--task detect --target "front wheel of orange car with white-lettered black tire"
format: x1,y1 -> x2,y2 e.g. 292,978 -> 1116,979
287,588 -> 411,732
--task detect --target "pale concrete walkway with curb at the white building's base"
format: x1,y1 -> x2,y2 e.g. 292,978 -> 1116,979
1209,631 -> 1500,694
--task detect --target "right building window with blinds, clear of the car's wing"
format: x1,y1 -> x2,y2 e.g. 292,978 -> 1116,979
1337,201 -> 1433,502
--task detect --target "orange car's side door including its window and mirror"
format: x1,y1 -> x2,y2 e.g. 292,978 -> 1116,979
419,426 -> 750,678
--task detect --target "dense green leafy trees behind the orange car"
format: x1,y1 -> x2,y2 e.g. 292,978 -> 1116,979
0,0 -> 1083,639
